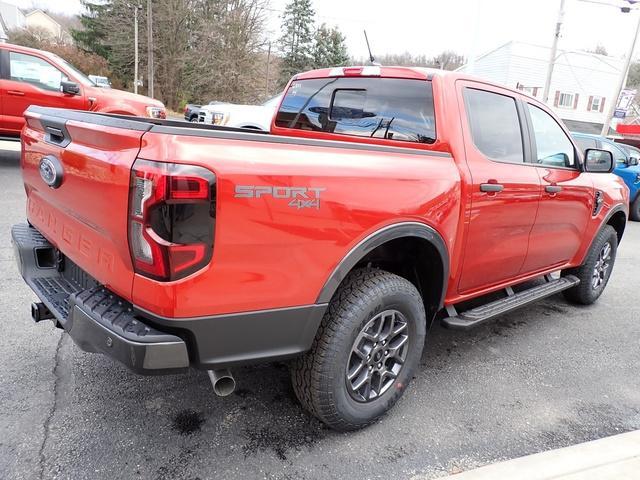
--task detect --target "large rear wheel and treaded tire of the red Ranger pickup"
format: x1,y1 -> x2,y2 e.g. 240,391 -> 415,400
291,269 -> 426,431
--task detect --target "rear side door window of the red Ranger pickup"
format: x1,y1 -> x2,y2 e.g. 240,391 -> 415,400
464,88 -> 524,163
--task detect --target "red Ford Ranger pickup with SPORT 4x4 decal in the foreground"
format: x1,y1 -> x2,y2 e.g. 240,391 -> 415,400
13,67 -> 629,430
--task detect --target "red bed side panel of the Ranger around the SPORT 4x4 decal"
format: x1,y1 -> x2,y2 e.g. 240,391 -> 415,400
133,133 -> 461,317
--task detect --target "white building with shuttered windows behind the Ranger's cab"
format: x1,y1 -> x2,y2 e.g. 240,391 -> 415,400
458,41 -> 624,133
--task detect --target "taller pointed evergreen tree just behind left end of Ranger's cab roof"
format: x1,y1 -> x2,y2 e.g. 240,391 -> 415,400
279,0 -> 315,85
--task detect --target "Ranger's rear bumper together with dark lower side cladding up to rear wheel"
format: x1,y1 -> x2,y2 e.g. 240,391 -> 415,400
11,224 -> 327,374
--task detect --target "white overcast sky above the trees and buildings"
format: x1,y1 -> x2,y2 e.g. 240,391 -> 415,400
5,0 -> 640,62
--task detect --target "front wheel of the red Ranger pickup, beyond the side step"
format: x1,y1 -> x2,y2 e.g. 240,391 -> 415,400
562,225 -> 618,305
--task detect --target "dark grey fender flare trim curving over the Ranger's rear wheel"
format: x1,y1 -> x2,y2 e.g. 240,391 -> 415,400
316,222 -> 449,308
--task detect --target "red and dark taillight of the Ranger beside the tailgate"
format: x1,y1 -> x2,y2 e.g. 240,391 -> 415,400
129,160 -> 216,281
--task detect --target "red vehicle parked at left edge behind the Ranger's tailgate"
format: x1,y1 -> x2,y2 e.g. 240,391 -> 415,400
0,43 -> 166,136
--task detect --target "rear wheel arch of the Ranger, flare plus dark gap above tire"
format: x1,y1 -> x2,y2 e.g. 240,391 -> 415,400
316,222 -> 449,320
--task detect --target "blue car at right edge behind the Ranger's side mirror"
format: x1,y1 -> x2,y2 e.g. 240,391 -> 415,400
571,133 -> 640,222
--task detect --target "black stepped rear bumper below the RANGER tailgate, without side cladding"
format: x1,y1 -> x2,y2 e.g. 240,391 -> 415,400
11,224 -> 189,374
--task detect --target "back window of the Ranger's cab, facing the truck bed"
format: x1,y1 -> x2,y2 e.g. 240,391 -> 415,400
276,77 -> 436,143
